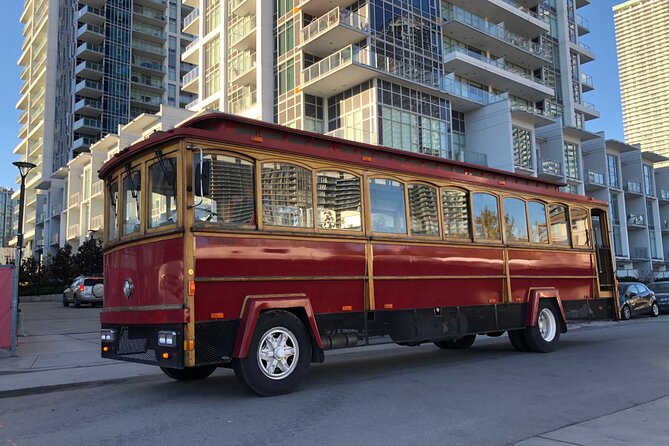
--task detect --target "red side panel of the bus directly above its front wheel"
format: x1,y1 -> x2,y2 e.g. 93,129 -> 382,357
195,236 -> 365,321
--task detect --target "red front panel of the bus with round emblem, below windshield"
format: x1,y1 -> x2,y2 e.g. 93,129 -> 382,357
100,237 -> 186,323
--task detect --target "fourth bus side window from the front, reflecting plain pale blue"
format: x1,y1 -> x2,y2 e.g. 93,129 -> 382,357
369,178 -> 407,234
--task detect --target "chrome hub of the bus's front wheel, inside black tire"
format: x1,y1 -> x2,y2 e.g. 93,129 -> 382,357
258,327 -> 300,379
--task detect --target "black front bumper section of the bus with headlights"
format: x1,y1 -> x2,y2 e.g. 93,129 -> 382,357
101,324 -> 184,369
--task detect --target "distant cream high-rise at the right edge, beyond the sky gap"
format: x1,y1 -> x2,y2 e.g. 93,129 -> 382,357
613,0 -> 669,160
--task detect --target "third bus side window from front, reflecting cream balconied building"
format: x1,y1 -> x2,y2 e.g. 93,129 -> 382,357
316,170 -> 362,231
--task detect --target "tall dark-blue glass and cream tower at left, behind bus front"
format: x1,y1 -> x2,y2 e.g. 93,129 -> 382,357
14,0 -> 194,254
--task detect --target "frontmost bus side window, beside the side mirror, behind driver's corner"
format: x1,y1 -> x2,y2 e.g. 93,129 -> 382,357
193,154 -> 256,226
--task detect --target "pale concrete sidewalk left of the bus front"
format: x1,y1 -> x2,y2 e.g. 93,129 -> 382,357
0,301 -> 162,398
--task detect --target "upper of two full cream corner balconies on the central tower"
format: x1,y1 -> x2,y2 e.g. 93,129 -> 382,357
302,7 -> 369,57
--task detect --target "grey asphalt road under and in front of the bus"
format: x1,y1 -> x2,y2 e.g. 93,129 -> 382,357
0,316 -> 669,446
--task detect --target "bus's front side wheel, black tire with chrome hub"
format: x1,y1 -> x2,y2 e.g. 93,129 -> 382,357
232,310 -> 311,396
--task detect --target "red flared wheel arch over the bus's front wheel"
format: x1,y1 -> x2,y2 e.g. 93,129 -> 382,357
232,293 -> 325,362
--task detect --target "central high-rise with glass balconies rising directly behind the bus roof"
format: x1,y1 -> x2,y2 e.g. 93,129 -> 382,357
182,0 -> 599,193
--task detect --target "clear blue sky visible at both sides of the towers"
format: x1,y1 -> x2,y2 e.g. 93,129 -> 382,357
0,0 -> 624,189
